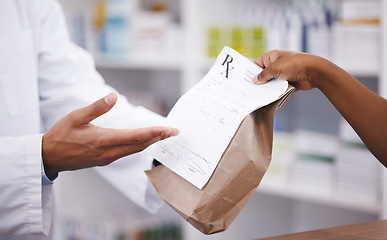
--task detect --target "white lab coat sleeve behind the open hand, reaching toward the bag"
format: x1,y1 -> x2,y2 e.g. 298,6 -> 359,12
38,0 -> 163,211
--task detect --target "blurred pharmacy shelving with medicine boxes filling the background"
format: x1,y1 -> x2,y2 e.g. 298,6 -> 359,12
55,0 -> 387,240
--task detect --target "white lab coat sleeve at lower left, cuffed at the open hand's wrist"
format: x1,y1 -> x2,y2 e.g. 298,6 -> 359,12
0,135 -> 52,235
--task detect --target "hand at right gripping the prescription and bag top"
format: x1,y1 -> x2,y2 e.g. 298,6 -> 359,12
253,50 -> 327,90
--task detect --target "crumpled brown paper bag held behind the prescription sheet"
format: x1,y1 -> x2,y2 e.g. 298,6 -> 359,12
146,87 -> 294,234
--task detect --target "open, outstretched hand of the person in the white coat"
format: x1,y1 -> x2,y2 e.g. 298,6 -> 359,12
42,93 -> 179,176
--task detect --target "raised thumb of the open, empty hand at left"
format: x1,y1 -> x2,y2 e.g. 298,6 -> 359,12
74,93 -> 117,125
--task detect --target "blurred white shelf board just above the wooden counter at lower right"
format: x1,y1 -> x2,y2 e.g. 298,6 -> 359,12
257,178 -> 382,214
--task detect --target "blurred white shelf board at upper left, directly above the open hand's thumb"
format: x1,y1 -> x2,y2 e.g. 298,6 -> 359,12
94,54 -> 182,71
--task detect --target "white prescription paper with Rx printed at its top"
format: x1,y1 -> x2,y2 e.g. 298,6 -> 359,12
147,47 -> 288,189
